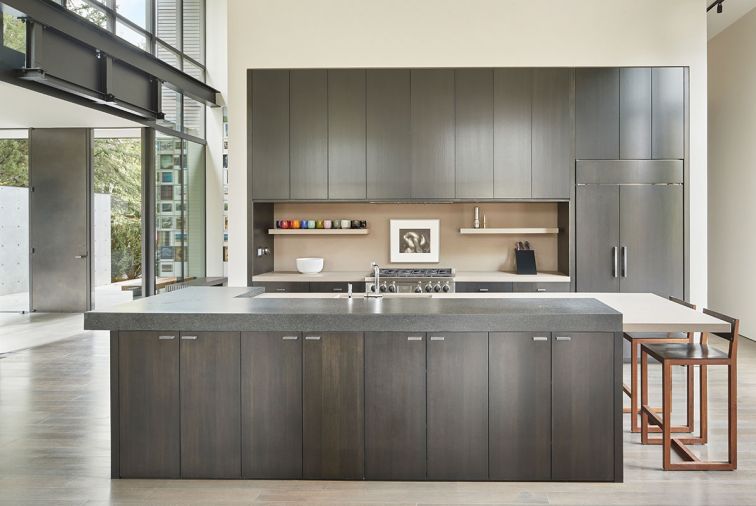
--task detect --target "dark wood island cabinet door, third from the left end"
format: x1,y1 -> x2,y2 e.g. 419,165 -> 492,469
241,332 -> 302,479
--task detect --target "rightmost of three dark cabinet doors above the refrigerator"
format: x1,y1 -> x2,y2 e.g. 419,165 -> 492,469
651,67 -> 685,160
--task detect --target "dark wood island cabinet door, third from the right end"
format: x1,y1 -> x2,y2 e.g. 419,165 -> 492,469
427,332 -> 488,480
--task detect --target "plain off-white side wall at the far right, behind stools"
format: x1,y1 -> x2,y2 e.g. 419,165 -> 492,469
709,4 -> 756,339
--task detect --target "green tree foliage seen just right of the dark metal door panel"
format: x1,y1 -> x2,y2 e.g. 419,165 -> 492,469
94,139 -> 142,282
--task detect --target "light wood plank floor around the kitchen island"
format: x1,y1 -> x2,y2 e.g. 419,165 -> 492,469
0,326 -> 756,506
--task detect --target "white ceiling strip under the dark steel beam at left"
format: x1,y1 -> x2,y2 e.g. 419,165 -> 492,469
0,81 -> 141,128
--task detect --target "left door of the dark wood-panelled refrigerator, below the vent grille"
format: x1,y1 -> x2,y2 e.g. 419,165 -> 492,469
575,185 -> 620,292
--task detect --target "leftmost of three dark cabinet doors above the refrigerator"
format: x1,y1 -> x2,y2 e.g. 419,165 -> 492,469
575,68 -> 620,160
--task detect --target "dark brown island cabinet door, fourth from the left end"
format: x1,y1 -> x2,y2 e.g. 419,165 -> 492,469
302,332 -> 365,479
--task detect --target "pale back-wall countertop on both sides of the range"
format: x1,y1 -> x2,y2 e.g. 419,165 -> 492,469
252,270 -> 570,283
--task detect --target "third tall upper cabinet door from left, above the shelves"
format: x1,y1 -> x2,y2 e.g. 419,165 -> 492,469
328,69 -> 367,199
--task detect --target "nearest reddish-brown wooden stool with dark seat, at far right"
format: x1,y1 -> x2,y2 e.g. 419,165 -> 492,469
641,309 -> 740,471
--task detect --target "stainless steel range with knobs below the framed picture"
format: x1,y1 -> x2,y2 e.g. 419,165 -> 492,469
365,268 -> 454,293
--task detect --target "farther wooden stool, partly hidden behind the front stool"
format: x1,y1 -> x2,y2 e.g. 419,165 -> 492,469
622,296 -> 696,432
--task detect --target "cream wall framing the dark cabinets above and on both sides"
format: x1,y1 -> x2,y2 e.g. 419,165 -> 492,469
228,0 -> 707,303
